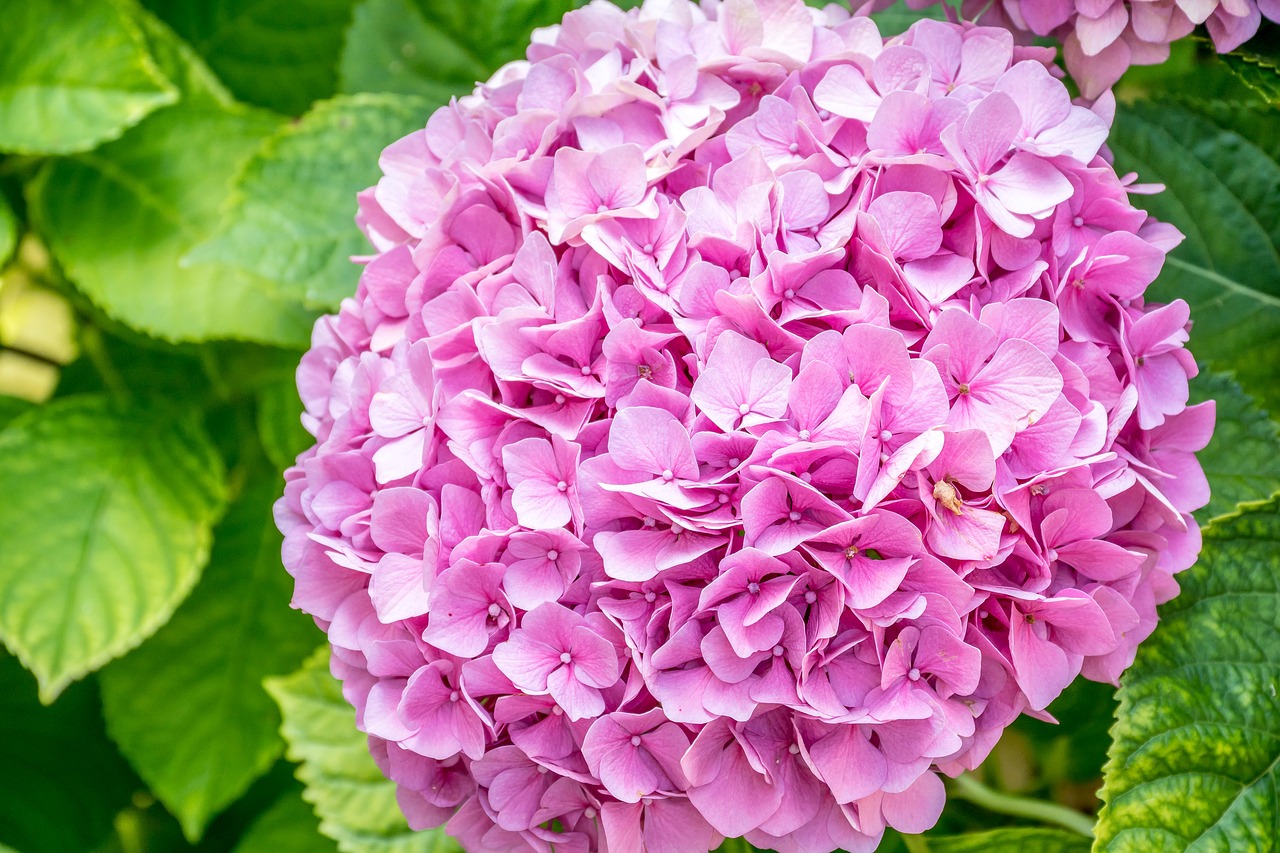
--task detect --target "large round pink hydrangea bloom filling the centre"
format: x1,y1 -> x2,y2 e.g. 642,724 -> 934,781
278,0 -> 1213,853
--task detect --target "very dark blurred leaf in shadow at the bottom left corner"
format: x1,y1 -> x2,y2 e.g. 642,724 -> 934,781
0,652 -> 138,853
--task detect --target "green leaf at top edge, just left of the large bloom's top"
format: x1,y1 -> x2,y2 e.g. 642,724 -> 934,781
338,0 -> 573,104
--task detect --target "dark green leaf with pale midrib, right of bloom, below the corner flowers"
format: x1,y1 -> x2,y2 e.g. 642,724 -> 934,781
1108,102 -> 1280,411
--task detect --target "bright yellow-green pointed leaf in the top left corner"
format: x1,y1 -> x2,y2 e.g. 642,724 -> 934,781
0,0 -> 178,154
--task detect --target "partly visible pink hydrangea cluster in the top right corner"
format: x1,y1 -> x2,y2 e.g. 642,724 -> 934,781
890,0 -> 1280,99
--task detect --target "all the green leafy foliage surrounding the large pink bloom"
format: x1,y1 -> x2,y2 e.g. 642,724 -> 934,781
0,0 -> 1280,853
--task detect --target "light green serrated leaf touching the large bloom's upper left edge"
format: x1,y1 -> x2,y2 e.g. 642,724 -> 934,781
186,95 -> 430,309
